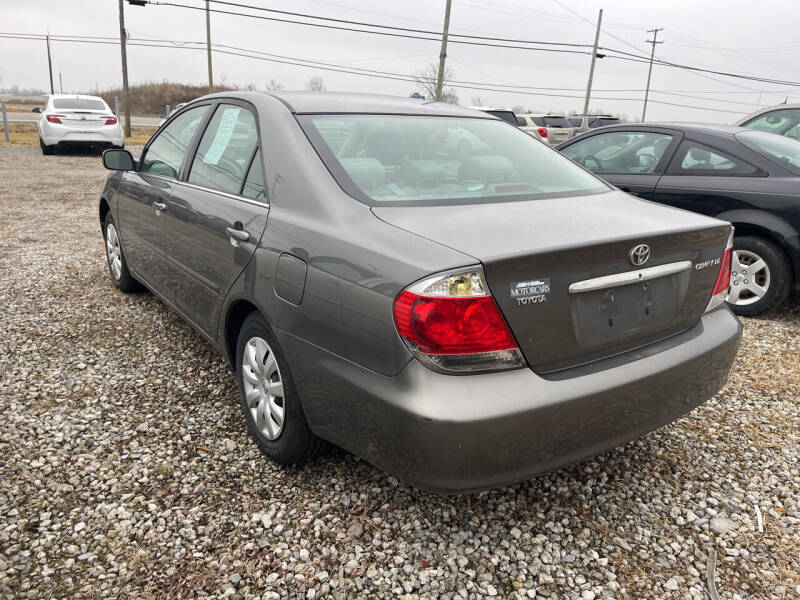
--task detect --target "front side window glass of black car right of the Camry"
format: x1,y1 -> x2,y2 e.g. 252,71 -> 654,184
562,131 -> 672,174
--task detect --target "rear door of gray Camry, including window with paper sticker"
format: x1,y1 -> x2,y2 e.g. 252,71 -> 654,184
164,100 -> 269,336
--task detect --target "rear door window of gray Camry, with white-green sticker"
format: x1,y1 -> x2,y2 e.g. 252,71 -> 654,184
189,104 -> 258,194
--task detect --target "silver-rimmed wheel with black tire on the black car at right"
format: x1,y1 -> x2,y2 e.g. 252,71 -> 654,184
728,236 -> 793,317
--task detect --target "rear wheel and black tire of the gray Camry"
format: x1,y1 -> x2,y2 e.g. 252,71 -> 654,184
236,312 -> 327,465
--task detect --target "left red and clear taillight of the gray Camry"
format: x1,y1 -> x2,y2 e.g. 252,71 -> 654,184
393,267 -> 525,373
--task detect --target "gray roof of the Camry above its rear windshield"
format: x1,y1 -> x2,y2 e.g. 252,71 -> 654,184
262,91 -> 490,118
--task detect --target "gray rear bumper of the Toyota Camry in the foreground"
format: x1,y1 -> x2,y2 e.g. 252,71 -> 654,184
278,307 -> 741,493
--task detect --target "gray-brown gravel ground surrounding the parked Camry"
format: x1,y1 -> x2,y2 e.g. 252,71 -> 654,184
0,146 -> 800,600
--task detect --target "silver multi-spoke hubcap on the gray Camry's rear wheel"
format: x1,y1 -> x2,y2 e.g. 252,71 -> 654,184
242,337 -> 286,440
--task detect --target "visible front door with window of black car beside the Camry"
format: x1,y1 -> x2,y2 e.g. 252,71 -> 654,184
559,129 -> 681,199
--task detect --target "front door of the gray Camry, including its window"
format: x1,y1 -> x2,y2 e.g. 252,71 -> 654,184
117,104 -> 209,301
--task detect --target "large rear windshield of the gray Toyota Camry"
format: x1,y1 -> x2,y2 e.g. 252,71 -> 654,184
300,115 -> 608,205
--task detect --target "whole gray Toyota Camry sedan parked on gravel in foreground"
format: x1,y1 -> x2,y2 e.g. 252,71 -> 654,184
99,92 -> 741,492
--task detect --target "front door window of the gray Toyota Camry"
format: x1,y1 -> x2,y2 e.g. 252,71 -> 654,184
139,106 -> 208,179
